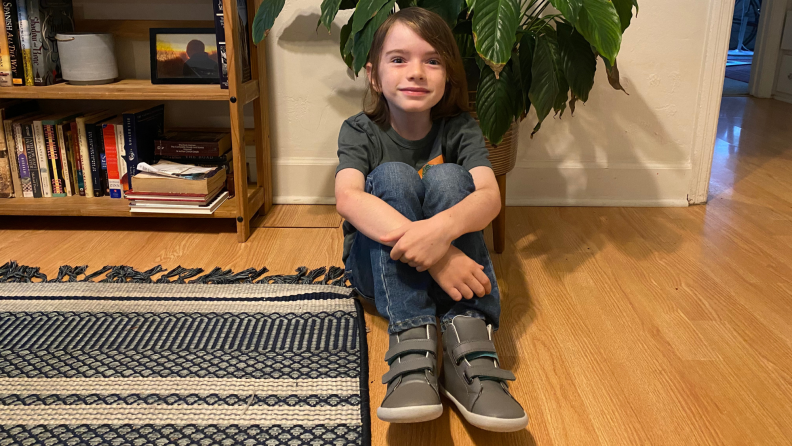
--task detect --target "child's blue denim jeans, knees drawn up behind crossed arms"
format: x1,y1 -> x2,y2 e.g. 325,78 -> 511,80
346,162 -> 500,334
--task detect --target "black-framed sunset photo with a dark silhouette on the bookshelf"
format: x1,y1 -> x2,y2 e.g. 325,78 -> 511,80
149,28 -> 220,84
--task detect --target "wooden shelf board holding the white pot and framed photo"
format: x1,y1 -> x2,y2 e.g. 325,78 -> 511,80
0,79 -> 258,103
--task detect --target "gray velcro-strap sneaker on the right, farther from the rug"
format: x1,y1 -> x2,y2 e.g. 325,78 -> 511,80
440,316 -> 528,432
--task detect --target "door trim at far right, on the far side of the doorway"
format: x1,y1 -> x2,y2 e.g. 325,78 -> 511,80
748,0 -> 787,98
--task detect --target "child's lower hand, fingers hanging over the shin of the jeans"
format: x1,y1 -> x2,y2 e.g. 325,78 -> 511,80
429,246 -> 492,301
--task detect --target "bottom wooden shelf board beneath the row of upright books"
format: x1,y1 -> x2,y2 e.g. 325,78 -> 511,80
0,184 -> 264,218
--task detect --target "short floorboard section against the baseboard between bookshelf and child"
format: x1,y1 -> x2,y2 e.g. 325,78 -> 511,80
251,204 -> 343,228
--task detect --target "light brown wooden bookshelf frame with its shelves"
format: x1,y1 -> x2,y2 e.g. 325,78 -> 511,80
0,0 -> 272,242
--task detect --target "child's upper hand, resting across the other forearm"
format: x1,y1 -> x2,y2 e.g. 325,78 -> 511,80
380,219 -> 451,271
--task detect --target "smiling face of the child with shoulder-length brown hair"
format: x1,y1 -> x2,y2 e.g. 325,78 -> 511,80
366,23 -> 446,113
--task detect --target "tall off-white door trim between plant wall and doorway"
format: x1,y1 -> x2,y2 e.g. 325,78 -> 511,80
687,0 -> 734,204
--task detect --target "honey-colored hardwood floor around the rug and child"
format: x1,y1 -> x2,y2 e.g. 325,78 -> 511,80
0,98 -> 792,446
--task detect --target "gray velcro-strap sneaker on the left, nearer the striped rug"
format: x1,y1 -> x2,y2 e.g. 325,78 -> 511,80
377,325 -> 443,423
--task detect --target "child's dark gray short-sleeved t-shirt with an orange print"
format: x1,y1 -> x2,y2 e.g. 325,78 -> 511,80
336,112 -> 492,263
